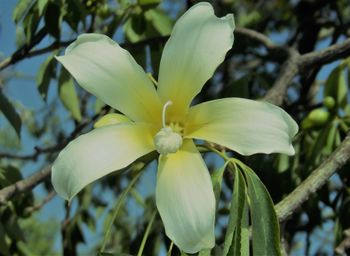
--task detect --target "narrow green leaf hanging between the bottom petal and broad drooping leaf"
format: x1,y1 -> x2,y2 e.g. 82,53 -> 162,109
222,162 -> 249,256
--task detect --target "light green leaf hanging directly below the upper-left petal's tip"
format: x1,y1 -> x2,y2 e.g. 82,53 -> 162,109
58,68 -> 81,122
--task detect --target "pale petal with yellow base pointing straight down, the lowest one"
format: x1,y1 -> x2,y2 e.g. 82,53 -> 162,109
156,140 -> 215,253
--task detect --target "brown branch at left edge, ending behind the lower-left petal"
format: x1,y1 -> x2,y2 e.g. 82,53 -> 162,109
0,166 -> 51,205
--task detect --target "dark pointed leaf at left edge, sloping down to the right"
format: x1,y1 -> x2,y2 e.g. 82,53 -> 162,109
0,89 -> 22,137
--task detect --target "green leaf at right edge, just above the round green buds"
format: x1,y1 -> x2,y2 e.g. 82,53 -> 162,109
324,64 -> 348,108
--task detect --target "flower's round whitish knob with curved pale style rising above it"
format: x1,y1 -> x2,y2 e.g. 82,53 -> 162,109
153,101 -> 182,155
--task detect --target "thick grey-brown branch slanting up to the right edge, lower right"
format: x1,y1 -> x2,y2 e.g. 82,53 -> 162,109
275,133 -> 350,222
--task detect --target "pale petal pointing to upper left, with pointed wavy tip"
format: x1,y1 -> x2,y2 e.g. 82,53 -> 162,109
57,34 -> 162,121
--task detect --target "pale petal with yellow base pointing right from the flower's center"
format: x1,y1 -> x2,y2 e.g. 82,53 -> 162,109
185,98 -> 298,155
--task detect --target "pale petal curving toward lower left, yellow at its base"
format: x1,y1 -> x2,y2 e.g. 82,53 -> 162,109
51,123 -> 154,200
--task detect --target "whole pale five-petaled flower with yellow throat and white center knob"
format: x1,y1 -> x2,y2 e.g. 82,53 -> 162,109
52,2 -> 298,253
